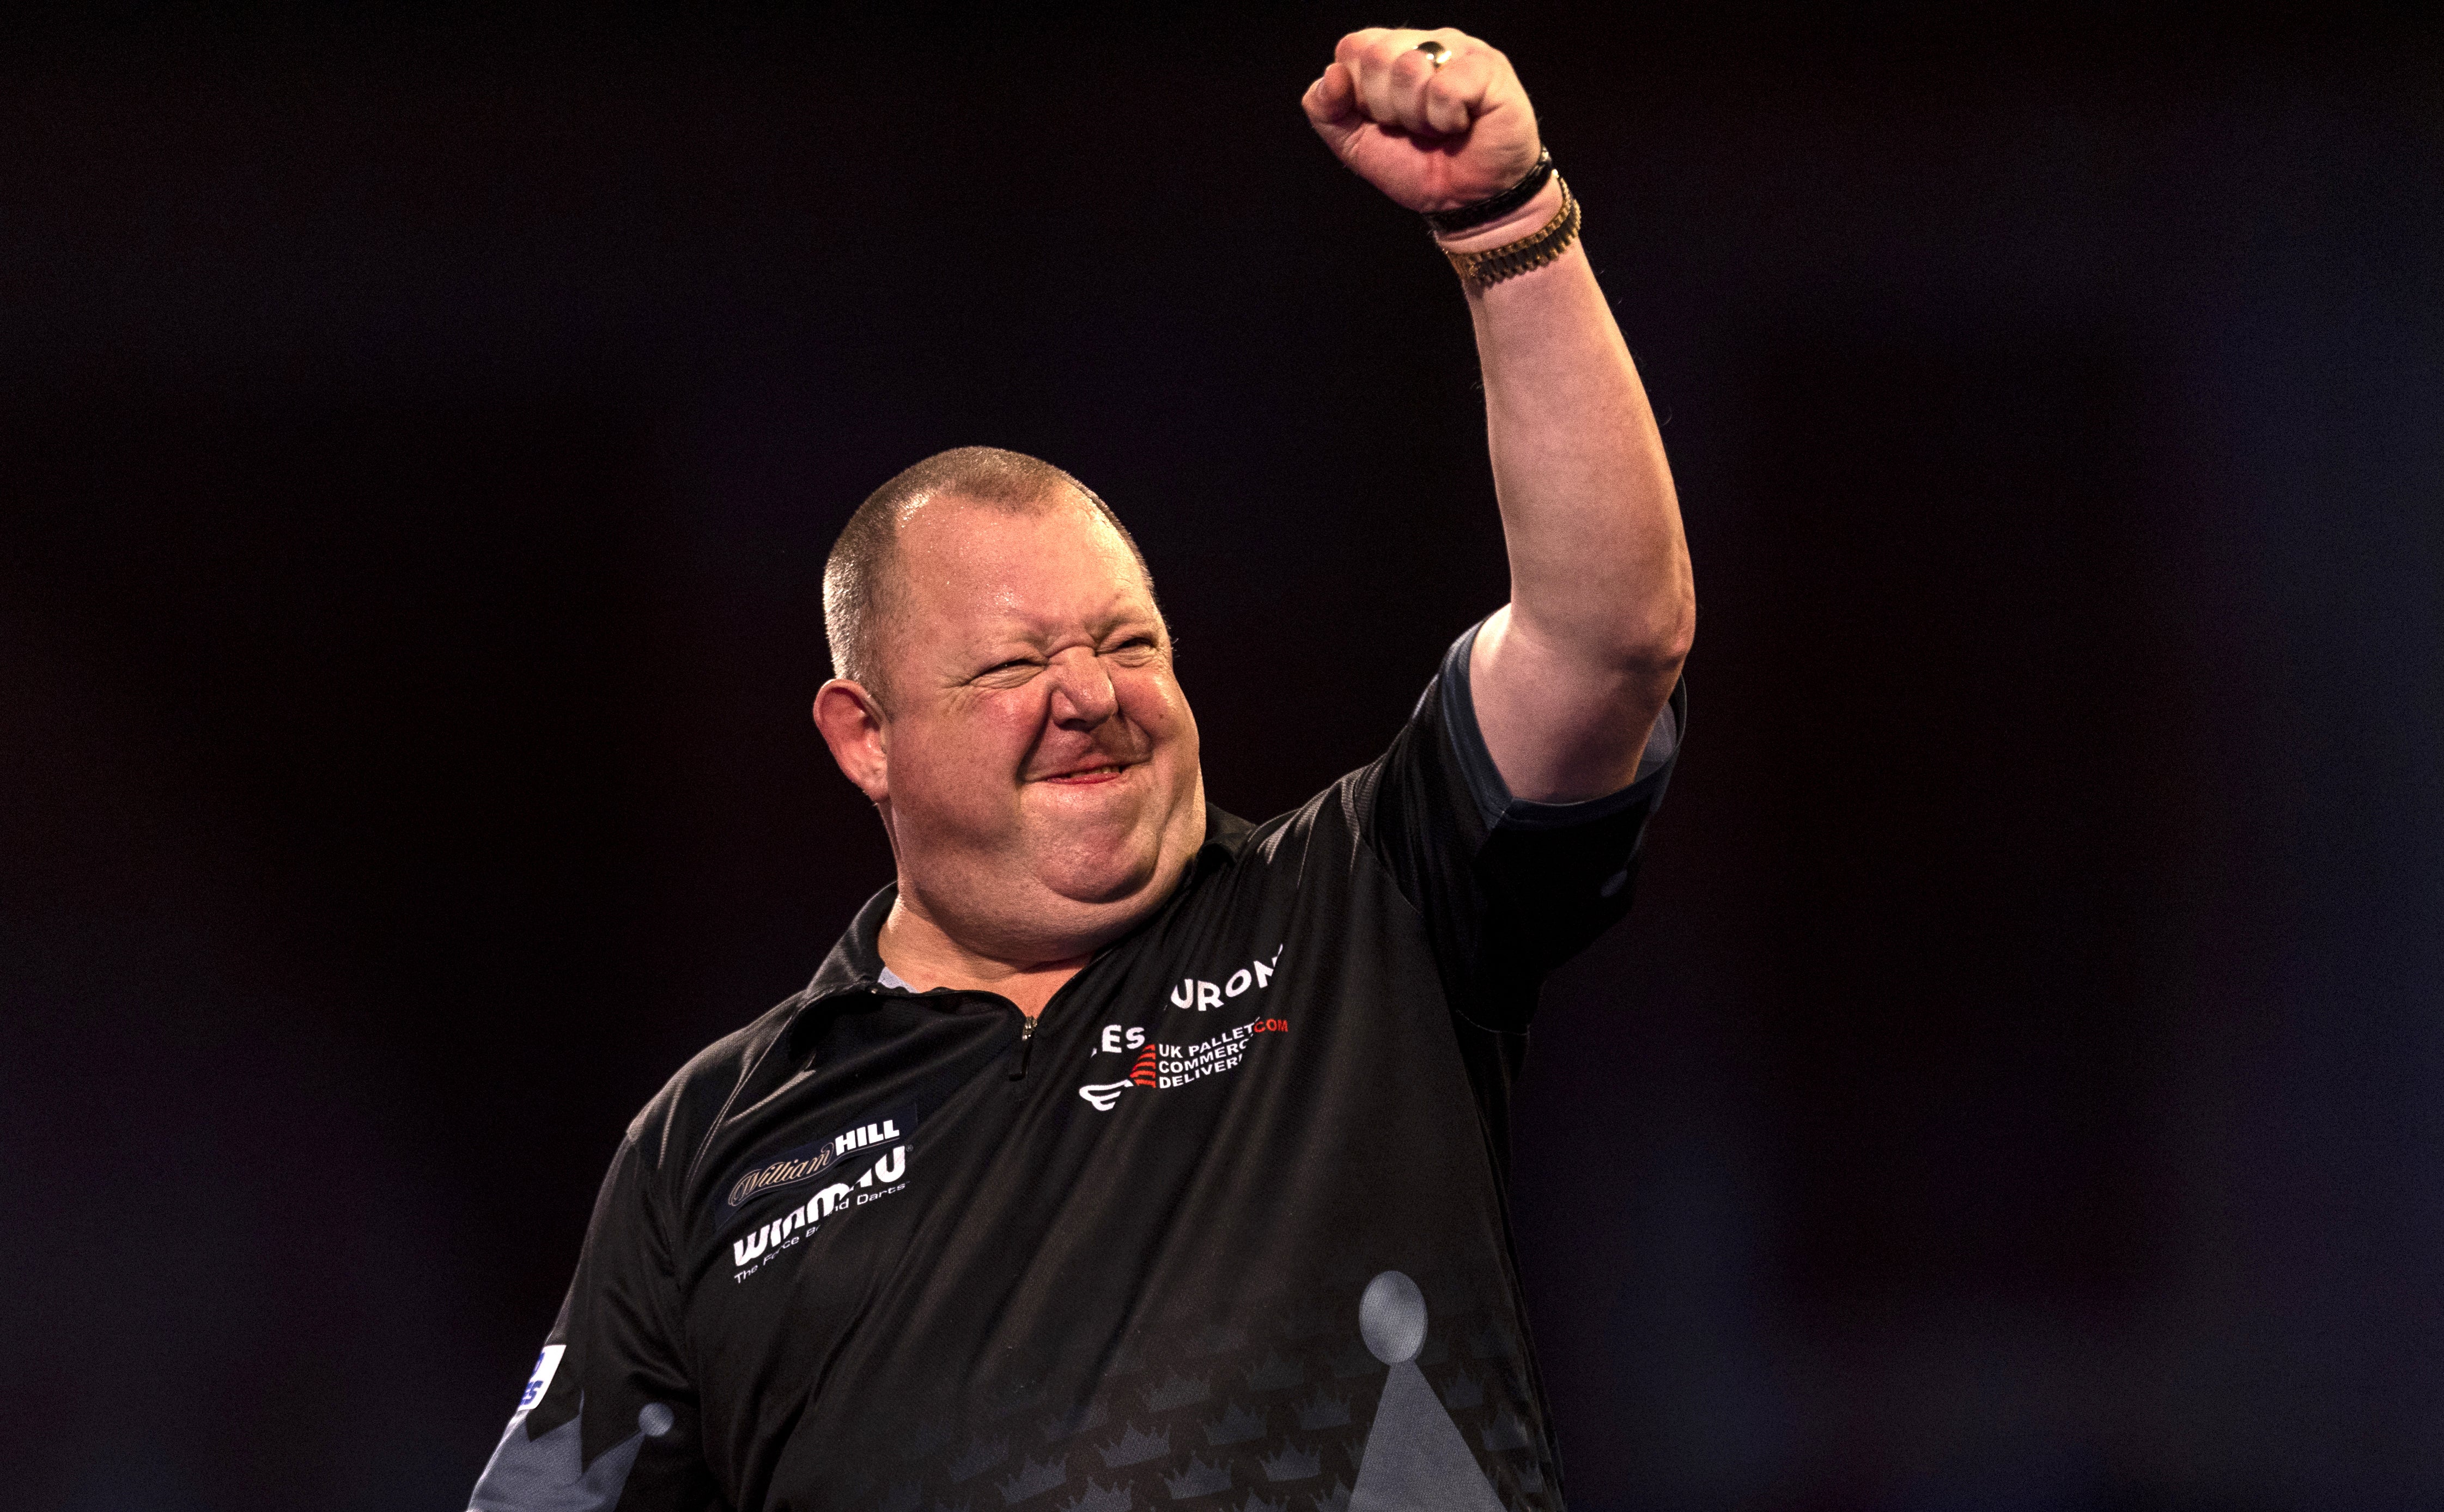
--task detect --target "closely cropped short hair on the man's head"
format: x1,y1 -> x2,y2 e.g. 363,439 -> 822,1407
824,447 -> 1153,699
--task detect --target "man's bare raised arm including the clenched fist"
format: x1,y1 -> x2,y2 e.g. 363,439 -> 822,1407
1305,27 -> 1696,803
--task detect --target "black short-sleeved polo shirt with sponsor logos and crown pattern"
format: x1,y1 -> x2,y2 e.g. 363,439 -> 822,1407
474,630 -> 1686,1512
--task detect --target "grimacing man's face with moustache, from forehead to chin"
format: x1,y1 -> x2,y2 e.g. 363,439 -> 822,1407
860,501 -> 1205,960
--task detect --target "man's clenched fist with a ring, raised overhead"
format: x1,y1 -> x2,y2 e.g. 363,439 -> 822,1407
1303,27 -> 1537,212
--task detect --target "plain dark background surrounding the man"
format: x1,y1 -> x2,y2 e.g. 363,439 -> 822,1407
0,5 -> 2444,1510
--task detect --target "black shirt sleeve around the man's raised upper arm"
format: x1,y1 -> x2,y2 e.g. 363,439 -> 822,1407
1361,625 -> 1689,1033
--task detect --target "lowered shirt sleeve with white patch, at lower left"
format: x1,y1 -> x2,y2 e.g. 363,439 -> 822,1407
467,1133 -> 721,1512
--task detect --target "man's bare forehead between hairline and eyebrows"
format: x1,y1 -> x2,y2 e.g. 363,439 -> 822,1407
897,496 -> 1153,640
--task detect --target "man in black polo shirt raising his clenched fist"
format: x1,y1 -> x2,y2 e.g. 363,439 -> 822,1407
474,29 -> 1694,1512
